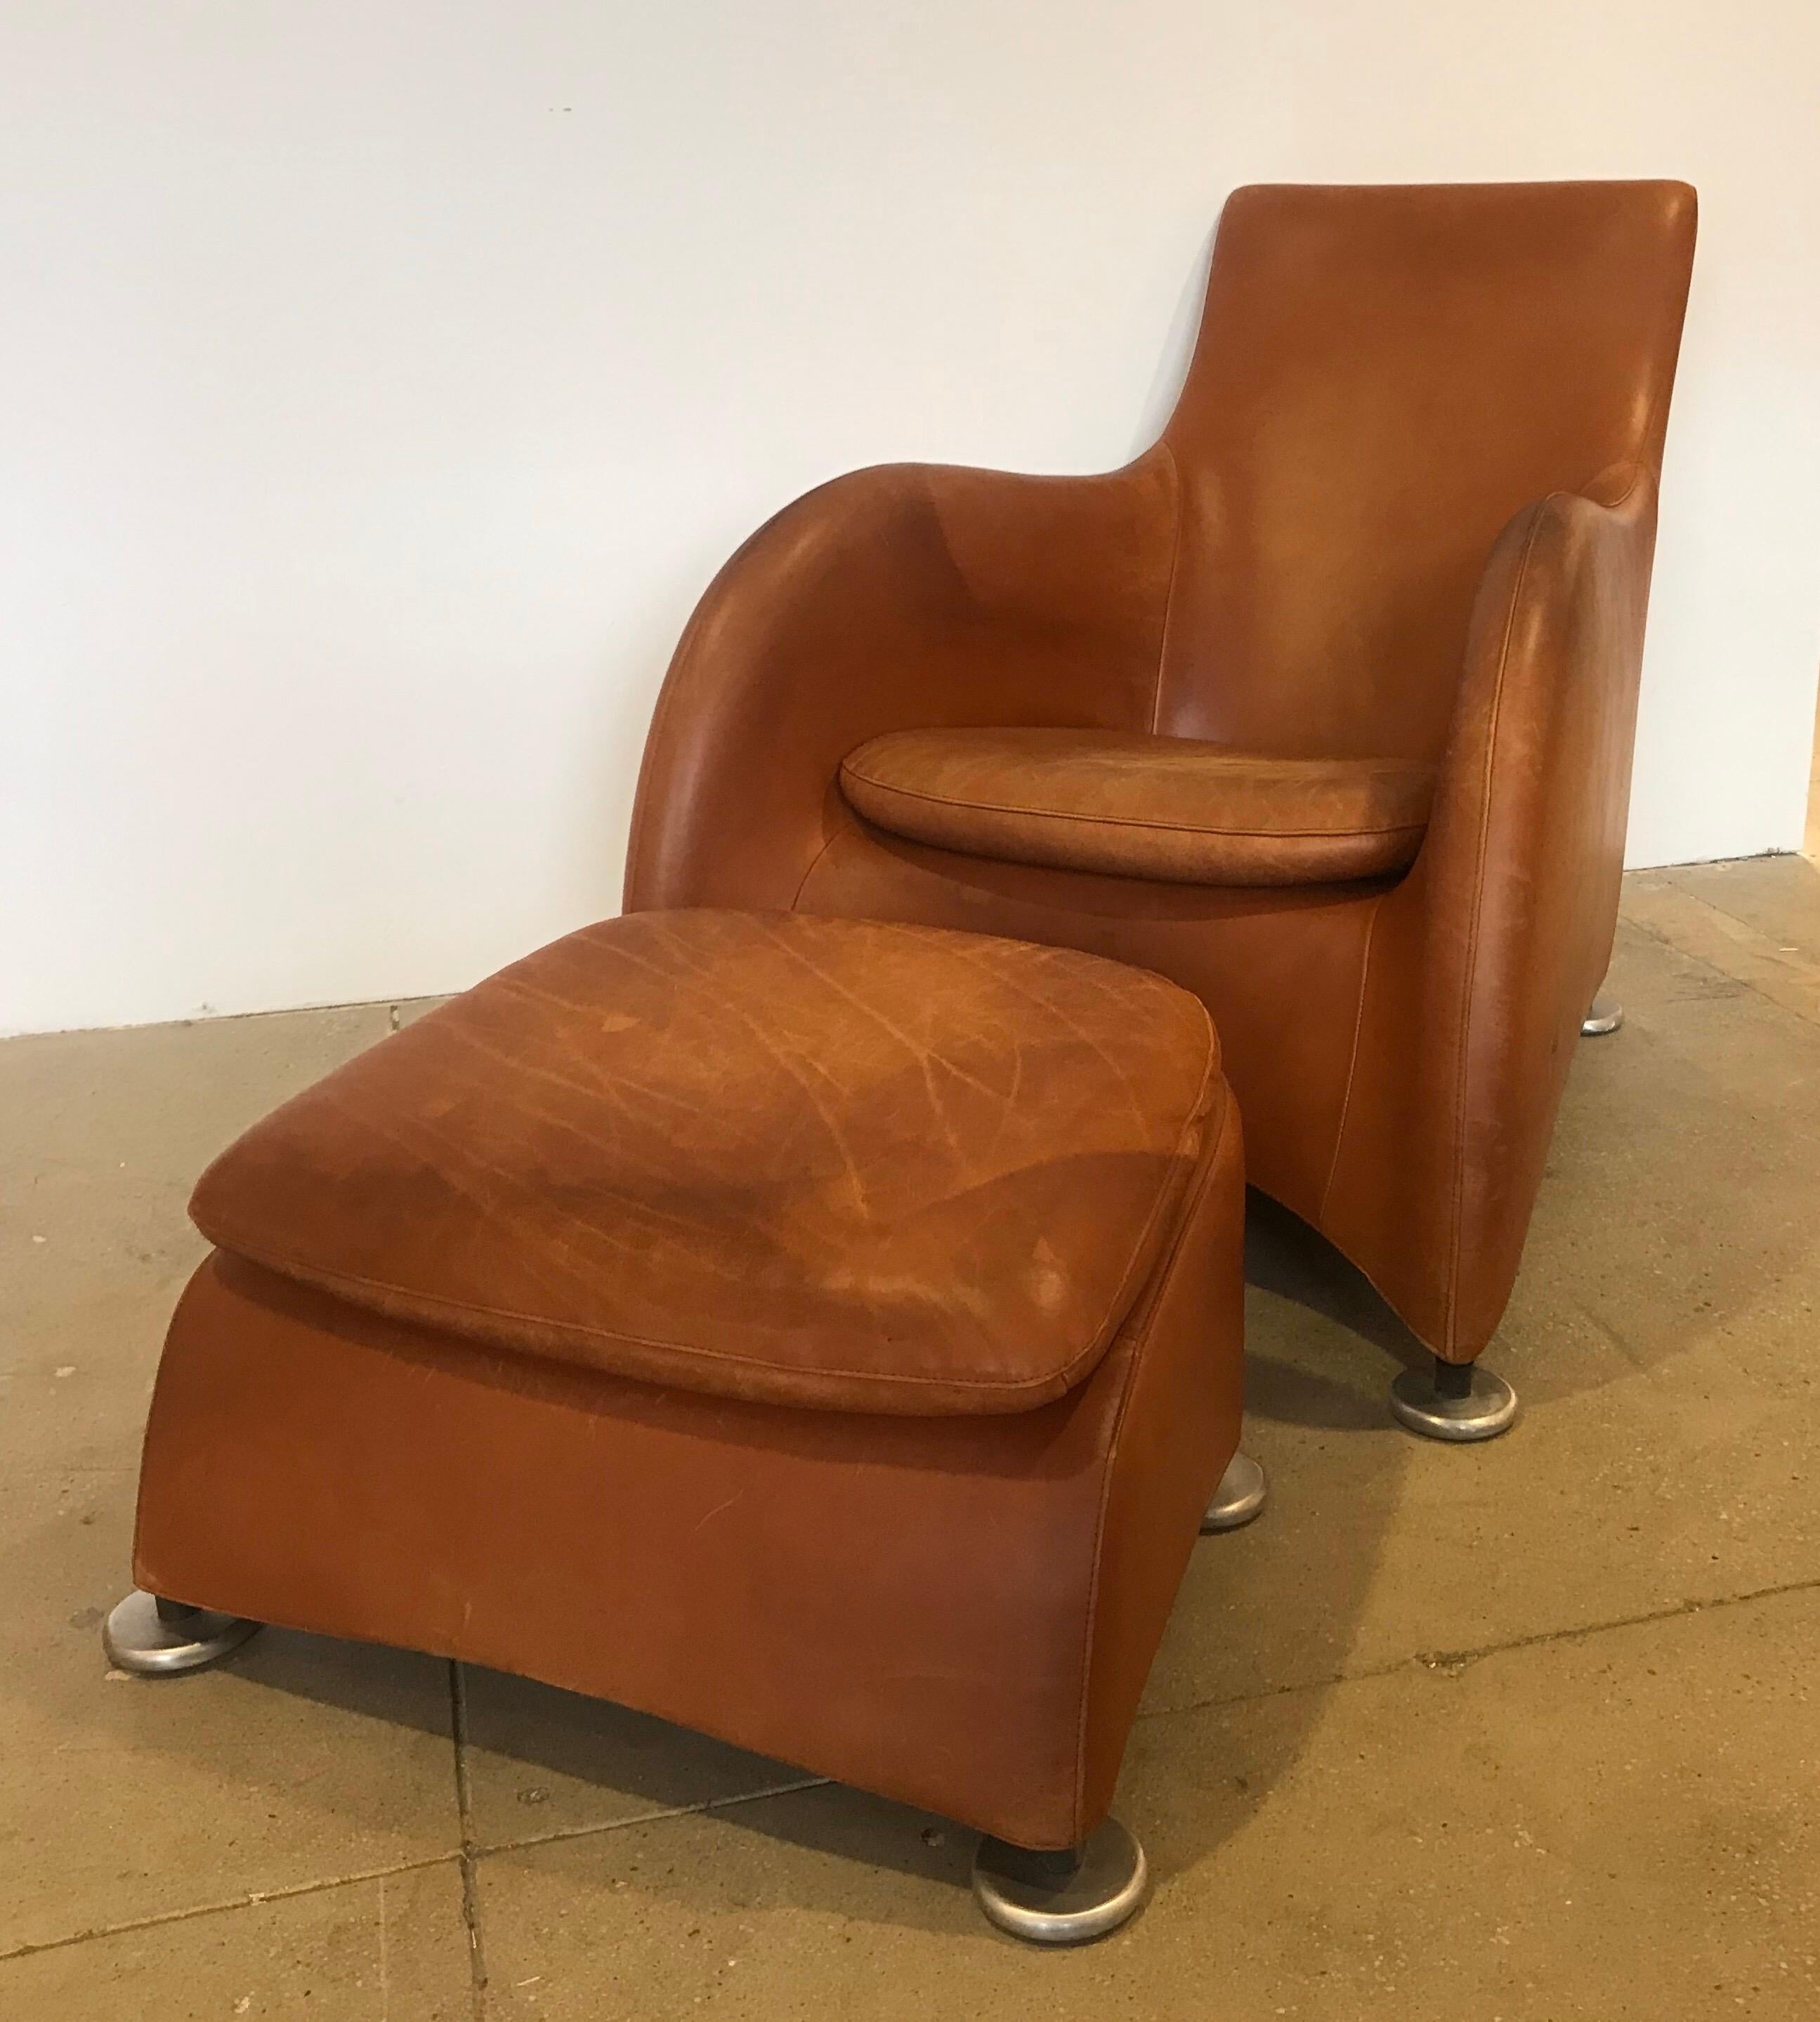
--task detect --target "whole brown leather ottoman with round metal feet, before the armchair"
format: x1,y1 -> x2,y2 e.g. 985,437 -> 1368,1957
107,912 -> 1256,1937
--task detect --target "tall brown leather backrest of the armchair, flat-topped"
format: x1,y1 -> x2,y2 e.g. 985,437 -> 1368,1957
1157,182 -> 1695,758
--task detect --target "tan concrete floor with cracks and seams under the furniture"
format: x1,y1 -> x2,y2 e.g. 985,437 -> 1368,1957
0,857 -> 1820,2022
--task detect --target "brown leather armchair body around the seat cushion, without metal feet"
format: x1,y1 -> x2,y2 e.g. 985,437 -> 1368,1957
625,182 -> 1695,1361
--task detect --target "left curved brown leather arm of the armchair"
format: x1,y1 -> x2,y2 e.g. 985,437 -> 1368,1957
625,445 -> 1177,912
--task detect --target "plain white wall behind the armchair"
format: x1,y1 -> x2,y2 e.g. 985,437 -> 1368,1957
0,0 -> 1820,1029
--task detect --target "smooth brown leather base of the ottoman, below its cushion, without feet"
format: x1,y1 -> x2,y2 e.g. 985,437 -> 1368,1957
133,1076 -> 1244,1846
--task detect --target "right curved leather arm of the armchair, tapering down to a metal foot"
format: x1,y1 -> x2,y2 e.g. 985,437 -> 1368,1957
1321,467 -> 1656,1361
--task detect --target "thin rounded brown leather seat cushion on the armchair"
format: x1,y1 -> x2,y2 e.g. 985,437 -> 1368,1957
842,730 -> 1434,886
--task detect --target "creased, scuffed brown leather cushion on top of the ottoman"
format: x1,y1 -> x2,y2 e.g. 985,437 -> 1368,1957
192,912 -> 1227,1414
